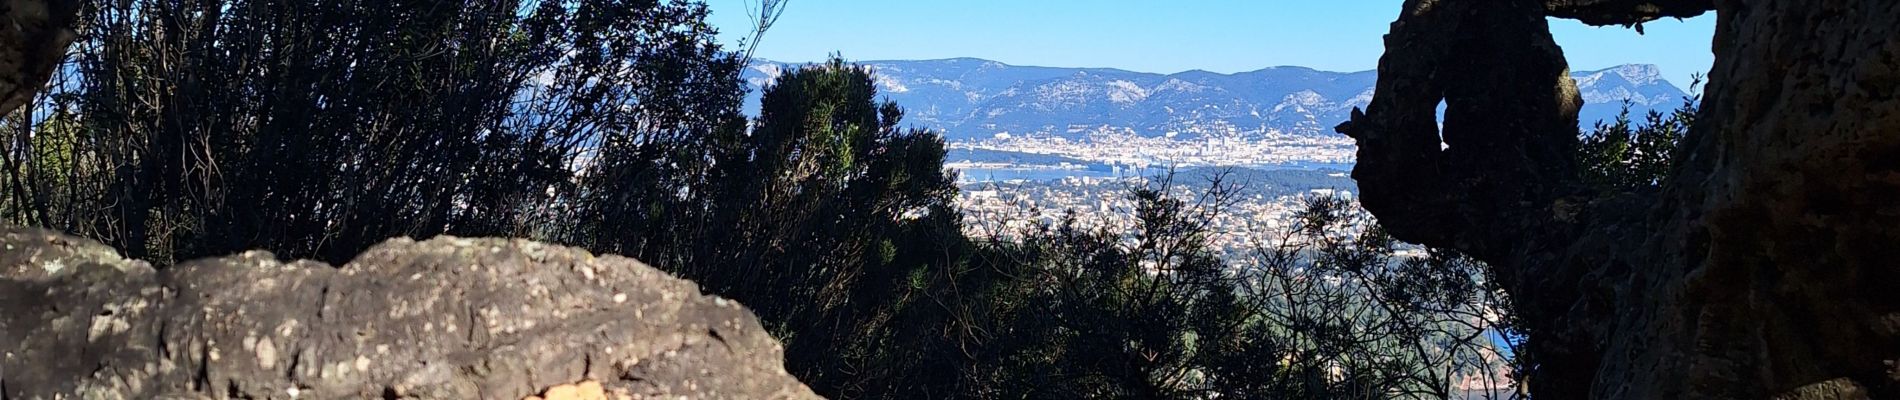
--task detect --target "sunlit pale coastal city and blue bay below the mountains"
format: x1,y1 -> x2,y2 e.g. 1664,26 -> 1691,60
946,129 -> 1383,256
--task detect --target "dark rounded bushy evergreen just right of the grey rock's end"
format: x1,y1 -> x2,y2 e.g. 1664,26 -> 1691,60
678,59 -> 963,385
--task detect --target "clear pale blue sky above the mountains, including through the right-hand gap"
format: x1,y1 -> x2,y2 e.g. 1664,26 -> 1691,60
707,0 -> 1714,85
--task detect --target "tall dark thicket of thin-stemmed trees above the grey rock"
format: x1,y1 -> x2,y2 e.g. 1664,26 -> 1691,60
4,0 -> 743,264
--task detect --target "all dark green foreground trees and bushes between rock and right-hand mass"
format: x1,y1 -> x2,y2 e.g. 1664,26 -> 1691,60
0,0 -> 1693,398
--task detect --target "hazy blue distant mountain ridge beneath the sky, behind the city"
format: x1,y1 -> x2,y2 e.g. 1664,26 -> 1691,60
745,59 -> 1687,140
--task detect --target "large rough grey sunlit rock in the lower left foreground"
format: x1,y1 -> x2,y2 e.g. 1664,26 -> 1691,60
0,227 -> 815,398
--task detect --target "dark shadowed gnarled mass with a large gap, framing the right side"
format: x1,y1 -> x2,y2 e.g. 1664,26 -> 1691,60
1340,0 -> 1900,398
